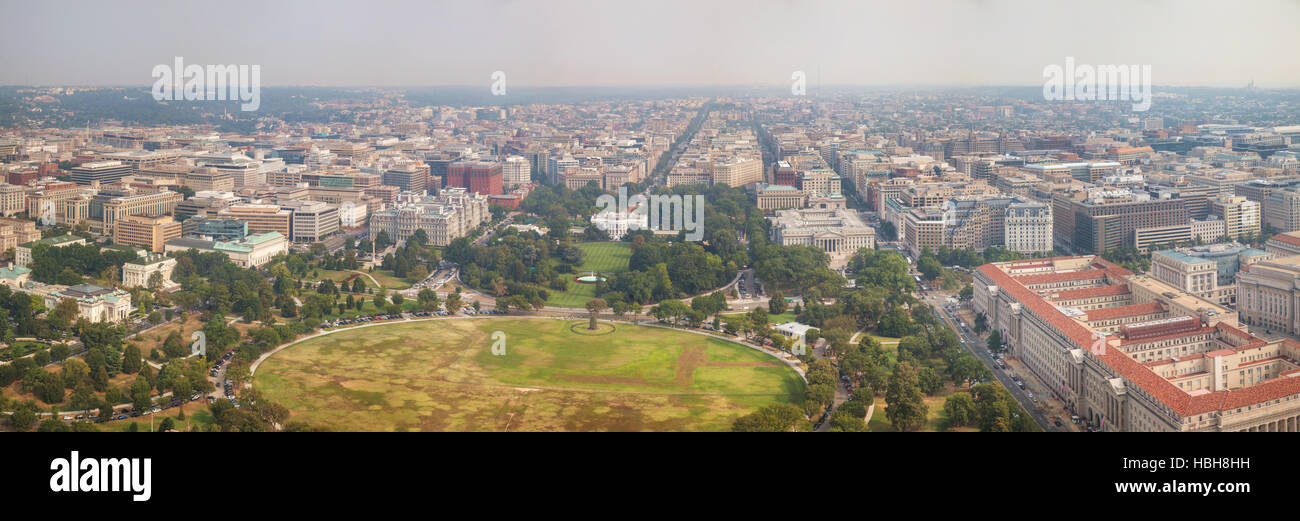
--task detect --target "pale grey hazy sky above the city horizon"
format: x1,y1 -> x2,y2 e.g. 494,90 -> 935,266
0,0 -> 1300,87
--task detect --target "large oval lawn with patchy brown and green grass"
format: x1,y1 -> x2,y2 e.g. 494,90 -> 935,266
255,318 -> 803,431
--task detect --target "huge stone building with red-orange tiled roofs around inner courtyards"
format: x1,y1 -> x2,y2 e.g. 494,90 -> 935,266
974,256 -> 1300,433
